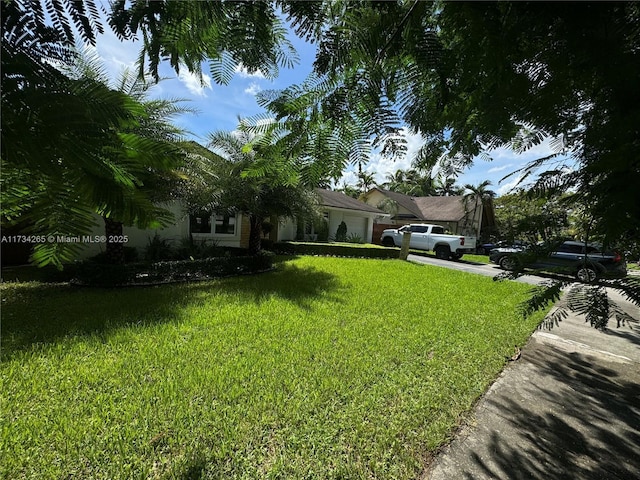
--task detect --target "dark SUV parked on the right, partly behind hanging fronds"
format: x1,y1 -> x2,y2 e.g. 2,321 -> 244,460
489,241 -> 627,282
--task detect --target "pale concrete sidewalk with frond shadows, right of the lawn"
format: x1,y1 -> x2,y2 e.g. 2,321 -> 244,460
422,286 -> 640,480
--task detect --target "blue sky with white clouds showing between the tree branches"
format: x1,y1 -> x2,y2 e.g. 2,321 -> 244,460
89,13 -> 551,195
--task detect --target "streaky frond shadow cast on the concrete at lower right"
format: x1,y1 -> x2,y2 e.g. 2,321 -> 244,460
465,344 -> 640,480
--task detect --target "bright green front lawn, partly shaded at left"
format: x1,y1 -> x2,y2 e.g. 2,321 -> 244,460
0,257 -> 541,479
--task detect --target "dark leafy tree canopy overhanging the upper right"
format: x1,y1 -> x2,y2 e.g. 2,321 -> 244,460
252,1 -> 640,246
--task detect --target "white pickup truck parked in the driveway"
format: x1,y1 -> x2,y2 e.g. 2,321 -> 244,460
380,223 -> 476,260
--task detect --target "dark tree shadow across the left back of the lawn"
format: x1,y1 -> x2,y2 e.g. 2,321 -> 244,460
0,264 -> 340,360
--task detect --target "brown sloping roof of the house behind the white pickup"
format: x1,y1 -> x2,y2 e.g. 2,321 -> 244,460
374,187 -> 465,222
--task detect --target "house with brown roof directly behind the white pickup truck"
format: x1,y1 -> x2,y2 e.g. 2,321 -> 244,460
364,187 -> 495,243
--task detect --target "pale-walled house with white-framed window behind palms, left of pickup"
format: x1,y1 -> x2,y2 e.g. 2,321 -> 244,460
74,189 -> 389,258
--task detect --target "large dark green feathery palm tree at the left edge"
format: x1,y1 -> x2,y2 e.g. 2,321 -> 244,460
2,47 -> 186,268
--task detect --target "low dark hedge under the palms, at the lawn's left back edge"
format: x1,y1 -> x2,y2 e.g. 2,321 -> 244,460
72,254 -> 273,287
